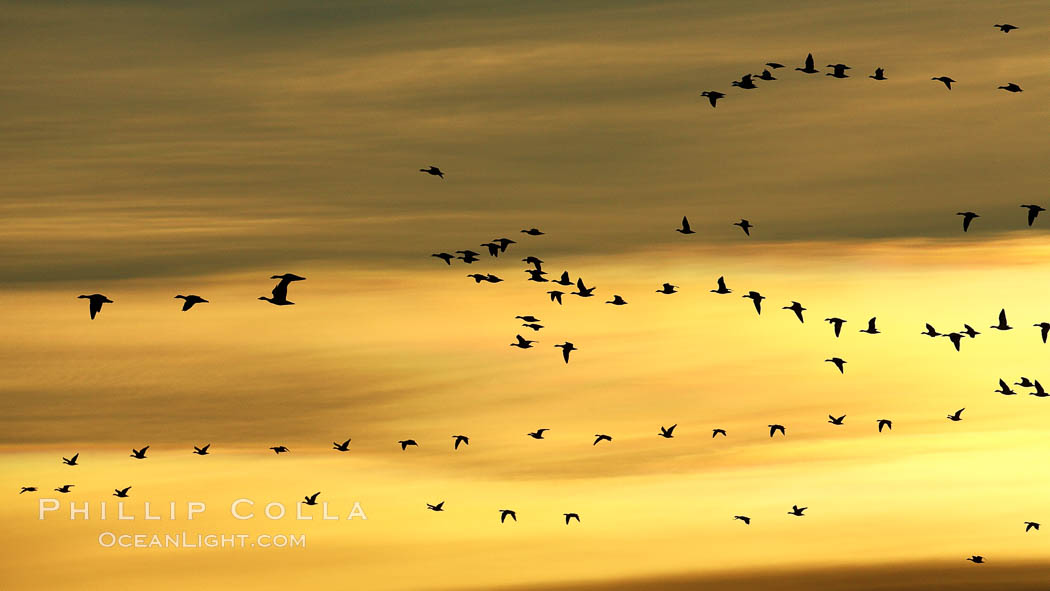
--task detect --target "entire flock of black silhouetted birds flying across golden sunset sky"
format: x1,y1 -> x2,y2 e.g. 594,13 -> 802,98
19,19 -> 1037,564
